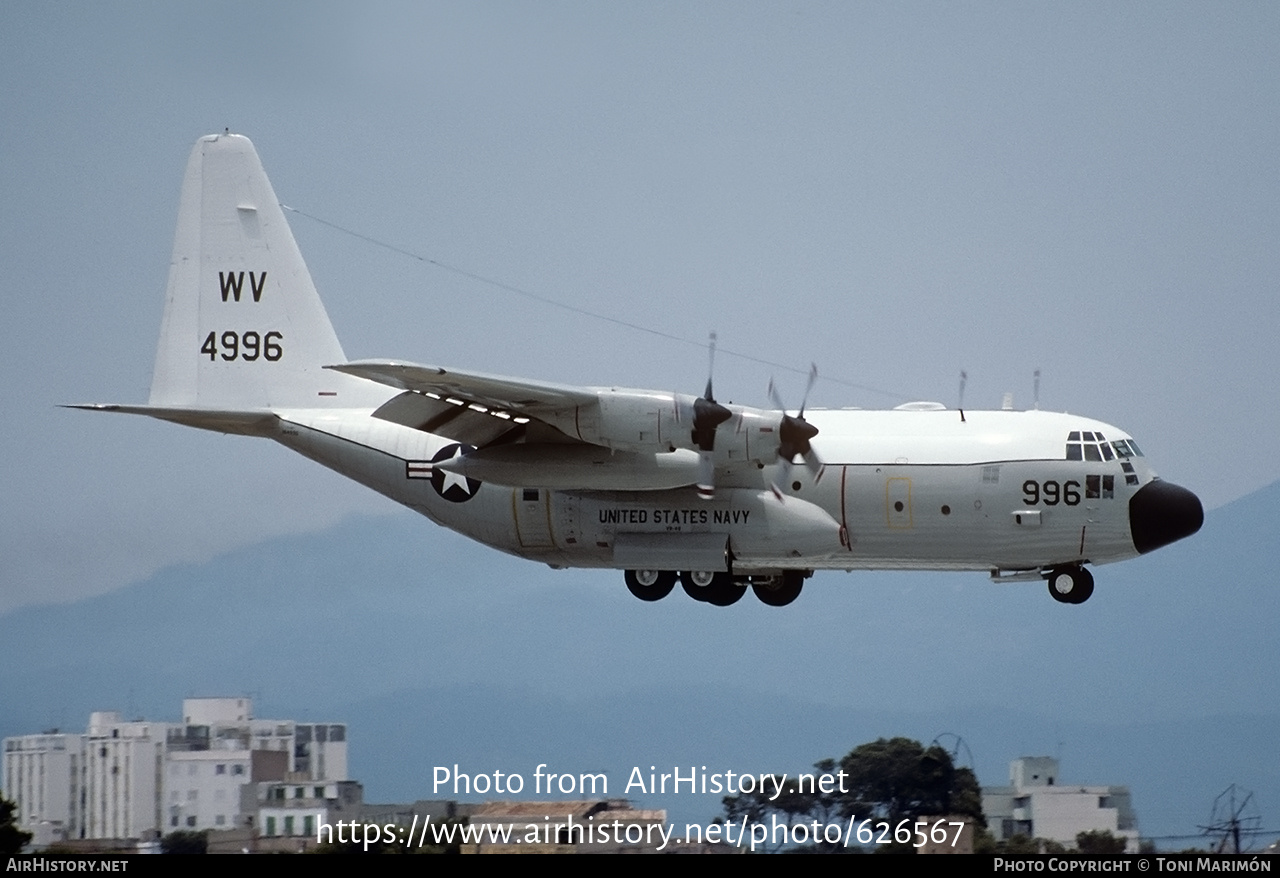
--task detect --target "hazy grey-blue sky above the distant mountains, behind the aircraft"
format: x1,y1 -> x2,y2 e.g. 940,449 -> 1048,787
0,3 -> 1280,613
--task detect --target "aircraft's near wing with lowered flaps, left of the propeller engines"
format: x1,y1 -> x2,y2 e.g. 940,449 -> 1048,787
325,360 -> 596,448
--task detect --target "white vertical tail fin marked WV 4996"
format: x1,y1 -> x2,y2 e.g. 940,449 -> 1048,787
150,134 -> 385,411
